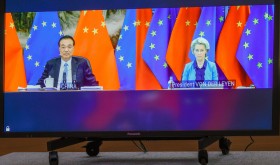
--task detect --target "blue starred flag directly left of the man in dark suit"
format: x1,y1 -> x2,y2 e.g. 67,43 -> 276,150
24,12 -> 63,85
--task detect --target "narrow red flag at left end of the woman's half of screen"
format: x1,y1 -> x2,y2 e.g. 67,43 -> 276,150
136,9 -> 161,90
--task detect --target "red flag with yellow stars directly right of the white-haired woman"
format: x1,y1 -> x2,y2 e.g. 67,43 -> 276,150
216,6 -> 252,87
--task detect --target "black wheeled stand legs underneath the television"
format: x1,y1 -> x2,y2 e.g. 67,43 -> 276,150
47,136 -> 231,165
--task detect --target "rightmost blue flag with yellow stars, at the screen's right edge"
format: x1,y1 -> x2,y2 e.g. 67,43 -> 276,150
236,5 -> 274,88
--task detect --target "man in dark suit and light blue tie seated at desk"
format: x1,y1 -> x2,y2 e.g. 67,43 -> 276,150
37,35 -> 98,88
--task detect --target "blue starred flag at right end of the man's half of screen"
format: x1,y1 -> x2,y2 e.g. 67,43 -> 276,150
115,9 -> 137,89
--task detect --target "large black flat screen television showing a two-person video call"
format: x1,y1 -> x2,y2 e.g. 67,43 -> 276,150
0,0 -> 280,139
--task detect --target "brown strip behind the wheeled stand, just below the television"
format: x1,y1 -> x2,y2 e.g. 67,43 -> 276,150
0,136 -> 280,155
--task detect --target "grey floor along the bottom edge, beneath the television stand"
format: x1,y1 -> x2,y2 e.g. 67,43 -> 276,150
0,151 -> 280,165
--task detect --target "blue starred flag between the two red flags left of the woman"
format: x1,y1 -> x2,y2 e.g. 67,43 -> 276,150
142,8 -> 179,88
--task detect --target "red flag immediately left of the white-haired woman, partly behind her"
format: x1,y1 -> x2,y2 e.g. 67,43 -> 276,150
166,7 -> 201,80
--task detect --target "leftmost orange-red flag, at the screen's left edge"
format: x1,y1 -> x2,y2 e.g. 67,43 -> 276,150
4,13 -> 26,92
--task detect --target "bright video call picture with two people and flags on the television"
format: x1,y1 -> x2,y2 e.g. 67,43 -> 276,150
5,5 -> 274,92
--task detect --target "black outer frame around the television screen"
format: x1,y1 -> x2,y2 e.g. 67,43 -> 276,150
0,0 -> 280,140
